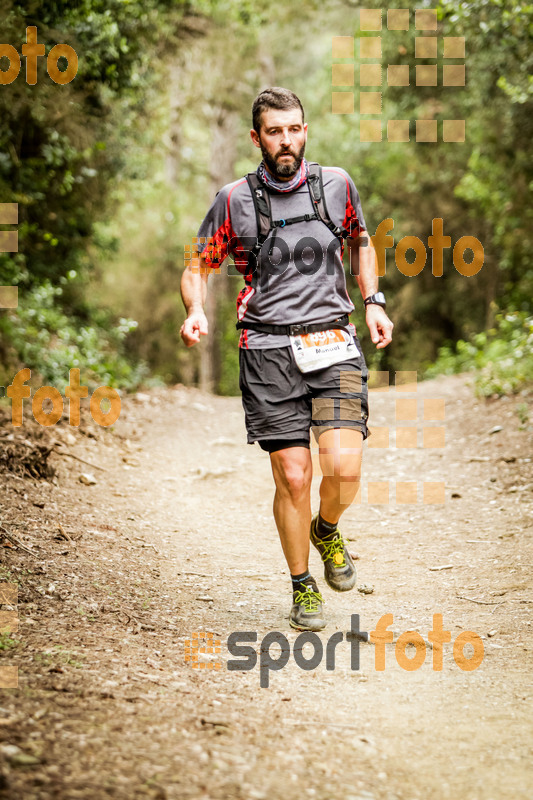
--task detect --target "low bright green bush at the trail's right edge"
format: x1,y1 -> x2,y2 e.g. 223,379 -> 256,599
426,312 -> 533,396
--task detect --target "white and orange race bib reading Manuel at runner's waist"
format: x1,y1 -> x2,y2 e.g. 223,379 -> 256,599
289,325 -> 359,372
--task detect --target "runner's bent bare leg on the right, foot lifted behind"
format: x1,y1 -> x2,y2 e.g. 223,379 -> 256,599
318,428 -> 363,524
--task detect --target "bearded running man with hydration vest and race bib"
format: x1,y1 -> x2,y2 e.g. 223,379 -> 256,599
180,87 -> 393,631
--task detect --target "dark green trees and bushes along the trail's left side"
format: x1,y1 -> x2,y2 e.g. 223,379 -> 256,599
0,0 -> 197,388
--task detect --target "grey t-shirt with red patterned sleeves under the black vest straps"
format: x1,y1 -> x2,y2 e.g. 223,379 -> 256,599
197,167 -> 366,349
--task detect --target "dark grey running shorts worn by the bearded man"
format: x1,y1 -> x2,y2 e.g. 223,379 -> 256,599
239,337 -> 368,444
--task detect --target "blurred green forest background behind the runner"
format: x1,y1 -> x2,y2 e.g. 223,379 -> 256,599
0,0 -> 533,395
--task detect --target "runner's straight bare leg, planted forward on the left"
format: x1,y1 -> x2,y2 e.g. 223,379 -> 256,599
270,447 -> 313,575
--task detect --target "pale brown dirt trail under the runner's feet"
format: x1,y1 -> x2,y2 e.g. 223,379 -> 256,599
0,377 -> 533,800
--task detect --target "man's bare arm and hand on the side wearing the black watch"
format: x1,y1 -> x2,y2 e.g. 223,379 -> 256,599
347,231 -> 394,349
